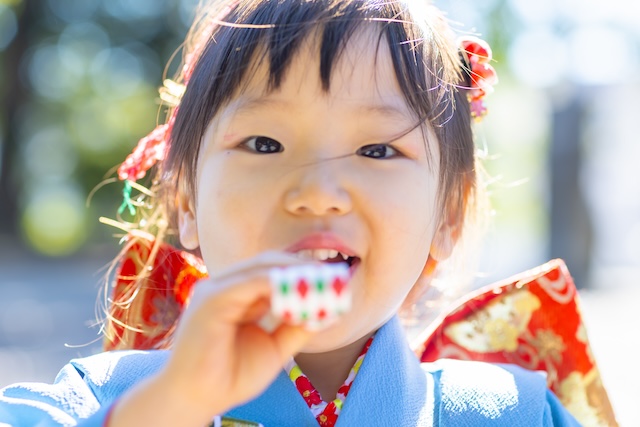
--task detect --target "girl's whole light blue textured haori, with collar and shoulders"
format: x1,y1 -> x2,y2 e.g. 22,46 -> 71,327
0,317 -> 579,427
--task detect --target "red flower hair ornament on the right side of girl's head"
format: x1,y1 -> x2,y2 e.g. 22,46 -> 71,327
459,36 -> 498,119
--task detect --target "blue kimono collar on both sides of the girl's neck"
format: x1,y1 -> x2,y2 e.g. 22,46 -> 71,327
226,317 -> 434,427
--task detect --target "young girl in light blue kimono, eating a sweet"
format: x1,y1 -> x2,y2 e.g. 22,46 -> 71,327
0,0 -> 577,427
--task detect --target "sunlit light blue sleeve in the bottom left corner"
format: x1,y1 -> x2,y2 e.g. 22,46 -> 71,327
0,364 -> 110,427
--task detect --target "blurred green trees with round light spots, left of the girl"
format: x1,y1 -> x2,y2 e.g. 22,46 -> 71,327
0,0 -> 197,255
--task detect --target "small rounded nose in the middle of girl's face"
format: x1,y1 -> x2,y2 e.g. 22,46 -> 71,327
285,161 -> 352,216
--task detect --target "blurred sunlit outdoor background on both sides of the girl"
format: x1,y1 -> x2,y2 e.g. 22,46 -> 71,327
0,0 -> 640,425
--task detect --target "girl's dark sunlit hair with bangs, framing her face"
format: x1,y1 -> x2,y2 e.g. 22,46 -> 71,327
101,0 -> 478,352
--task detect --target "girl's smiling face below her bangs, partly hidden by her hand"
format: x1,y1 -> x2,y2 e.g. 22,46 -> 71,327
179,28 -> 452,352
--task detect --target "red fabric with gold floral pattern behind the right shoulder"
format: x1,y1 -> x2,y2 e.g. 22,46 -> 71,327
414,260 -> 618,426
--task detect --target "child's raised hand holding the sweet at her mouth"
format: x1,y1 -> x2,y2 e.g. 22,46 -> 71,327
110,252 -> 312,426
